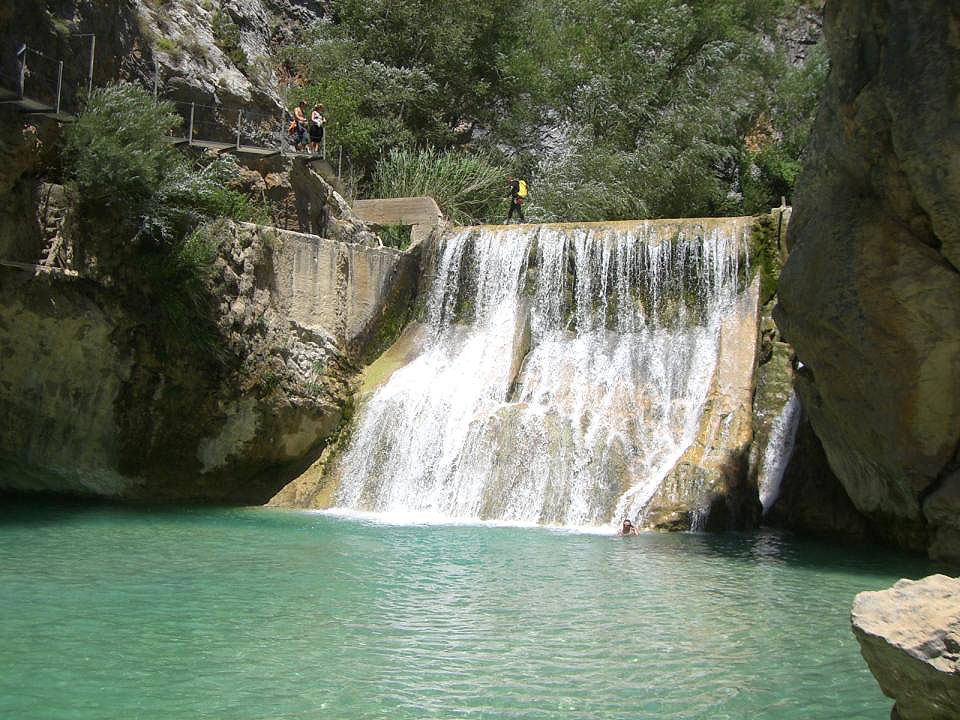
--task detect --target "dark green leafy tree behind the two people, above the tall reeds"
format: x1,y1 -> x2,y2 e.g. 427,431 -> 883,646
282,5 -> 529,177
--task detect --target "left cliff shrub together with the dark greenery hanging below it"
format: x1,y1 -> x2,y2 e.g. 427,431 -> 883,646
63,84 -> 263,350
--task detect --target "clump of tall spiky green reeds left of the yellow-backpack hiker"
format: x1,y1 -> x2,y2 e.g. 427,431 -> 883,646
372,148 -> 509,225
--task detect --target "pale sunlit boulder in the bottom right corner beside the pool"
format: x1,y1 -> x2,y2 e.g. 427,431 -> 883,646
850,575 -> 960,720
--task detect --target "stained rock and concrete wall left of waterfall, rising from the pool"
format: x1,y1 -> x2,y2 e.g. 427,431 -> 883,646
0,222 -> 416,503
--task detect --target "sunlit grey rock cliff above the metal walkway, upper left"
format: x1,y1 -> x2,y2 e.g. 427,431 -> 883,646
0,0 -> 328,116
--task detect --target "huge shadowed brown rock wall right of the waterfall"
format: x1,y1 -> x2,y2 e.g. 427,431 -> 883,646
775,0 -> 960,560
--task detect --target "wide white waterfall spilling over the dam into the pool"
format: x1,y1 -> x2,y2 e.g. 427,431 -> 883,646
335,220 -> 747,526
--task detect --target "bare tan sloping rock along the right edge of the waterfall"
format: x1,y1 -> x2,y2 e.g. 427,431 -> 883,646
640,277 -> 760,530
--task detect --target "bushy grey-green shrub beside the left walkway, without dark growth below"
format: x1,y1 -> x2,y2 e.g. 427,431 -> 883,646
63,84 -> 265,264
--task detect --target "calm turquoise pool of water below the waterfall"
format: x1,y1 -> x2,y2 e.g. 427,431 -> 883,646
0,504 -> 934,720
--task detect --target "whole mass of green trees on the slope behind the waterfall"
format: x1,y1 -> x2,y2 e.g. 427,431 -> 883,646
283,0 -> 826,220
